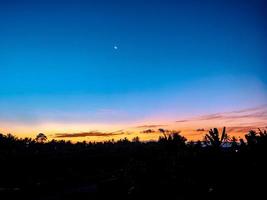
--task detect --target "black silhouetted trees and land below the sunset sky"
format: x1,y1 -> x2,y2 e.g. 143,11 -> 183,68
0,129 -> 267,200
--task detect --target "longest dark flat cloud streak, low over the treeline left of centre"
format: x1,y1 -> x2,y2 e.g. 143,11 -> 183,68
55,131 -> 124,138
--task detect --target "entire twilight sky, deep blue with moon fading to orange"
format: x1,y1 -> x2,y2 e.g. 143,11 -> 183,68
0,0 -> 267,140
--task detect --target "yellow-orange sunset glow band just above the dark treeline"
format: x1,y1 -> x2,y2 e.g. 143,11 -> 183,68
0,106 -> 267,142
